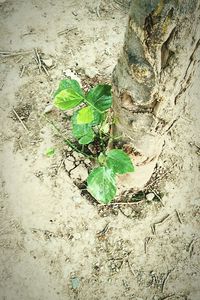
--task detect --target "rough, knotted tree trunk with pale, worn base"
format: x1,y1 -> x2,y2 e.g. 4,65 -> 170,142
113,0 -> 200,188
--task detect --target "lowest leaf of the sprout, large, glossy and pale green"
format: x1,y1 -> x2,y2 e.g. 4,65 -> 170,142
87,167 -> 116,204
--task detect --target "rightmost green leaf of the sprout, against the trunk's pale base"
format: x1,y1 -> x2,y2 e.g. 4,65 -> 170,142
106,149 -> 134,174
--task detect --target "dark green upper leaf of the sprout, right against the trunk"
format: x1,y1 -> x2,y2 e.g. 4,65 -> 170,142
86,84 -> 112,112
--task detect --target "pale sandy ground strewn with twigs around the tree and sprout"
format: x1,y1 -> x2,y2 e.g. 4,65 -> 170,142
0,0 -> 200,300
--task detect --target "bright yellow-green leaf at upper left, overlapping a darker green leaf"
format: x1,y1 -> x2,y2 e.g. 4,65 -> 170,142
54,88 -> 83,110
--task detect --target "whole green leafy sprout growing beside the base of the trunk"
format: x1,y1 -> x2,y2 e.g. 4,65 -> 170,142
54,79 -> 134,204
